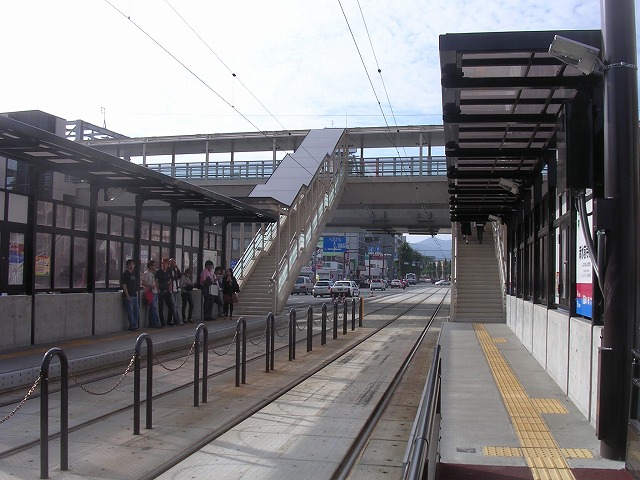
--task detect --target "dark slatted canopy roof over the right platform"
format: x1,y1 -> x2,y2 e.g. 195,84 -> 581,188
440,30 -> 602,221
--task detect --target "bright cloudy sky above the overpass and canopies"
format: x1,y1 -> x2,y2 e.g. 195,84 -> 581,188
0,0 -> 628,137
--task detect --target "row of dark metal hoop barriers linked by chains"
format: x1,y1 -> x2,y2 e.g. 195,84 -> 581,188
5,298 -> 364,478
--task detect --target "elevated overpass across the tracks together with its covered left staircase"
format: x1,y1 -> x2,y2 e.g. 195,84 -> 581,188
86,126 -> 451,314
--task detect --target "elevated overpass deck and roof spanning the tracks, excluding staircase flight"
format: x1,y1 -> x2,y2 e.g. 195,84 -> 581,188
87,125 -> 451,234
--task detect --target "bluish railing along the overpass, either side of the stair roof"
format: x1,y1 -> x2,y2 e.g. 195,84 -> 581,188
146,156 -> 447,180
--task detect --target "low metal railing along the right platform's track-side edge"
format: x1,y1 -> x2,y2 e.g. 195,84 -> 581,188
402,343 -> 441,480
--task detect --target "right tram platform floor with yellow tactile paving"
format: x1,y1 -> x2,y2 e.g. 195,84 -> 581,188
436,322 -> 632,480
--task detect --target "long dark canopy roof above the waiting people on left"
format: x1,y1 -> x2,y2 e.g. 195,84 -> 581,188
0,115 -> 277,222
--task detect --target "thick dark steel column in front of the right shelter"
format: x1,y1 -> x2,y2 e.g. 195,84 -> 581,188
598,0 -> 640,460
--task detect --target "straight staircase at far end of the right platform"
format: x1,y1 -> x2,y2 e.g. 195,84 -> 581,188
451,228 -> 505,323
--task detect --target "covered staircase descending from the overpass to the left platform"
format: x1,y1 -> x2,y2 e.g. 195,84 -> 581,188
234,131 -> 348,316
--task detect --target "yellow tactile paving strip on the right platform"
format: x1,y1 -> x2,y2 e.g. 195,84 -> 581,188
473,324 -> 592,480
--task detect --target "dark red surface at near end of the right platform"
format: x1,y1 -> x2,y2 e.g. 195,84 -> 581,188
436,463 -> 633,480
